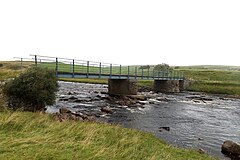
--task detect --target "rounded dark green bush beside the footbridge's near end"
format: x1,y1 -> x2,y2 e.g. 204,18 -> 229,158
3,67 -> 58,111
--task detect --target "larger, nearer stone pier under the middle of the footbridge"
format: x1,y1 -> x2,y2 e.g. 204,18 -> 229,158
108,79 -> 138,95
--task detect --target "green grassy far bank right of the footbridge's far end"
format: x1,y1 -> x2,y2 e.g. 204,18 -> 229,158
179,67 -> 240,95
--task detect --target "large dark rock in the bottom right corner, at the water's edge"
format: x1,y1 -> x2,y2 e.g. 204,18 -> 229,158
222,140 -> 240,155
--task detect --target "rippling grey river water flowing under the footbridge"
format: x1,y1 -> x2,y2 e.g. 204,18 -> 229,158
48,82 -> 240,159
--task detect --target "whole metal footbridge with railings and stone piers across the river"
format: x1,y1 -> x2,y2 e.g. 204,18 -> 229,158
15,55 -> 185,95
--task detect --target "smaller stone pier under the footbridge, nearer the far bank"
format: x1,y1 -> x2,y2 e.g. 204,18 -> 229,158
153,80 -> 180,93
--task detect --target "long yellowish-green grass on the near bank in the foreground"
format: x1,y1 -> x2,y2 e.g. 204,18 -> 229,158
0,112 -> 216,160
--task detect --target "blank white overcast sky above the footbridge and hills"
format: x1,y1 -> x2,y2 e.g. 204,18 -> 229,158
0,0 -> 240,66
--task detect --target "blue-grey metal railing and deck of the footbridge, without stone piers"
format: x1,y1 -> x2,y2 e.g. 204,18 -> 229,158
13,55 -> 184,80
